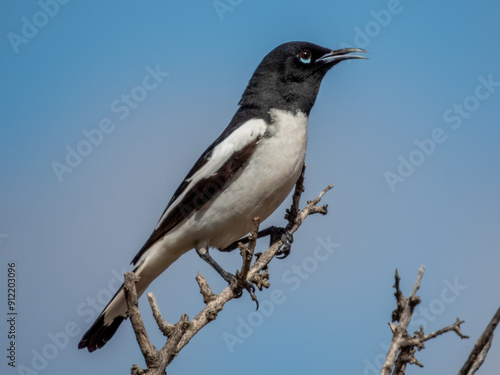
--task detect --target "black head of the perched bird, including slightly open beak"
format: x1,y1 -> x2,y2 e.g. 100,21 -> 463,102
239,42 -> 366,114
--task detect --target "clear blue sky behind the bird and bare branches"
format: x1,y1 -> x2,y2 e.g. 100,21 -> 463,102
0,0 -> 500,375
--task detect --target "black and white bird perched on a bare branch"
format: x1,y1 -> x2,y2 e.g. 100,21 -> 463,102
78,41 -> 368,352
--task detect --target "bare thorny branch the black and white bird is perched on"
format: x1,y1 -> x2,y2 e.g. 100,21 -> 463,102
125,165 -> 333,375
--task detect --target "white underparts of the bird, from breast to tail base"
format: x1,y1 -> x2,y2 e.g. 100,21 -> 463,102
136,110 -> 307,291
